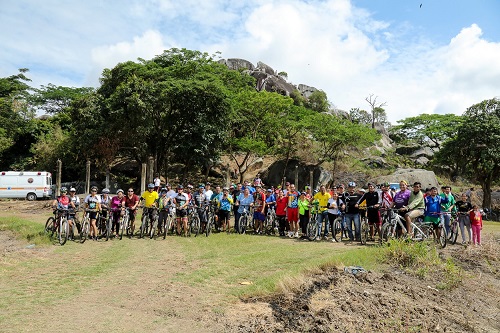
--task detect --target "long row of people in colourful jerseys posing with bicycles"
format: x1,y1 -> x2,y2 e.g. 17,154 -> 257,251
49,177 -> 482,244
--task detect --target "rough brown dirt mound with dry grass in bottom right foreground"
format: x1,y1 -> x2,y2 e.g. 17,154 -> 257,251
227,239 -> 500,332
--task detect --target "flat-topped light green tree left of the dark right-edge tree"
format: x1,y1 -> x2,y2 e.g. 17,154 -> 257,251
389,113 -> 464,150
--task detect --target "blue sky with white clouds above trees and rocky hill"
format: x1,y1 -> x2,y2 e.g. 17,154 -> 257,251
0,0 -> 500,123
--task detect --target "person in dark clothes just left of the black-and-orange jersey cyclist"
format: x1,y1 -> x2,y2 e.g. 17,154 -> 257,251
337,182 -> 361,241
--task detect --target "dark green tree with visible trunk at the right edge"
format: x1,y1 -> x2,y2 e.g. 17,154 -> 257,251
440,98 -> 500,208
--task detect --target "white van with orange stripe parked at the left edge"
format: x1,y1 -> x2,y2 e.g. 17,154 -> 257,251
0,171 -> 52,200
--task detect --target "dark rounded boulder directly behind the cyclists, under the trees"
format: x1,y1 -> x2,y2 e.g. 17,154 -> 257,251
261,160 -> 333,189
